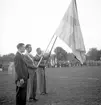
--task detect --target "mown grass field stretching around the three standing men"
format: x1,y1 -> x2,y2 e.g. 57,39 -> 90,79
0,67 -> 101,105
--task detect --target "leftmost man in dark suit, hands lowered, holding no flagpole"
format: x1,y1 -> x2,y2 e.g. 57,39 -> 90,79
14,43 -> 29,105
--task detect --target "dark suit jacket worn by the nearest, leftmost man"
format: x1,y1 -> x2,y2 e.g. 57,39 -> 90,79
14,52 -> 29,83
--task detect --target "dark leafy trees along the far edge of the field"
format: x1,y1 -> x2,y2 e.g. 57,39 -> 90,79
0,47 -> 101,64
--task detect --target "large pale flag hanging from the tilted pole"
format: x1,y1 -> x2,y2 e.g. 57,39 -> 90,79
55,0 -> 86,64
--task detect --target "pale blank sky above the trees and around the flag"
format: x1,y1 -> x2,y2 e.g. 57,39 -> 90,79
0,0 -> 101,54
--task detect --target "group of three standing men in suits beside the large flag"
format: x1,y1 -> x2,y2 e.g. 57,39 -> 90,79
14,43 -> 49,105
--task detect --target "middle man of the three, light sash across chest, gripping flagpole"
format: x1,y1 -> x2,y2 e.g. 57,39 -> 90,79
25,44 -> 37,102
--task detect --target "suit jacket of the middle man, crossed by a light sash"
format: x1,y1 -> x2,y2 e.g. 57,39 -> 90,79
24,55 -> 37,75
